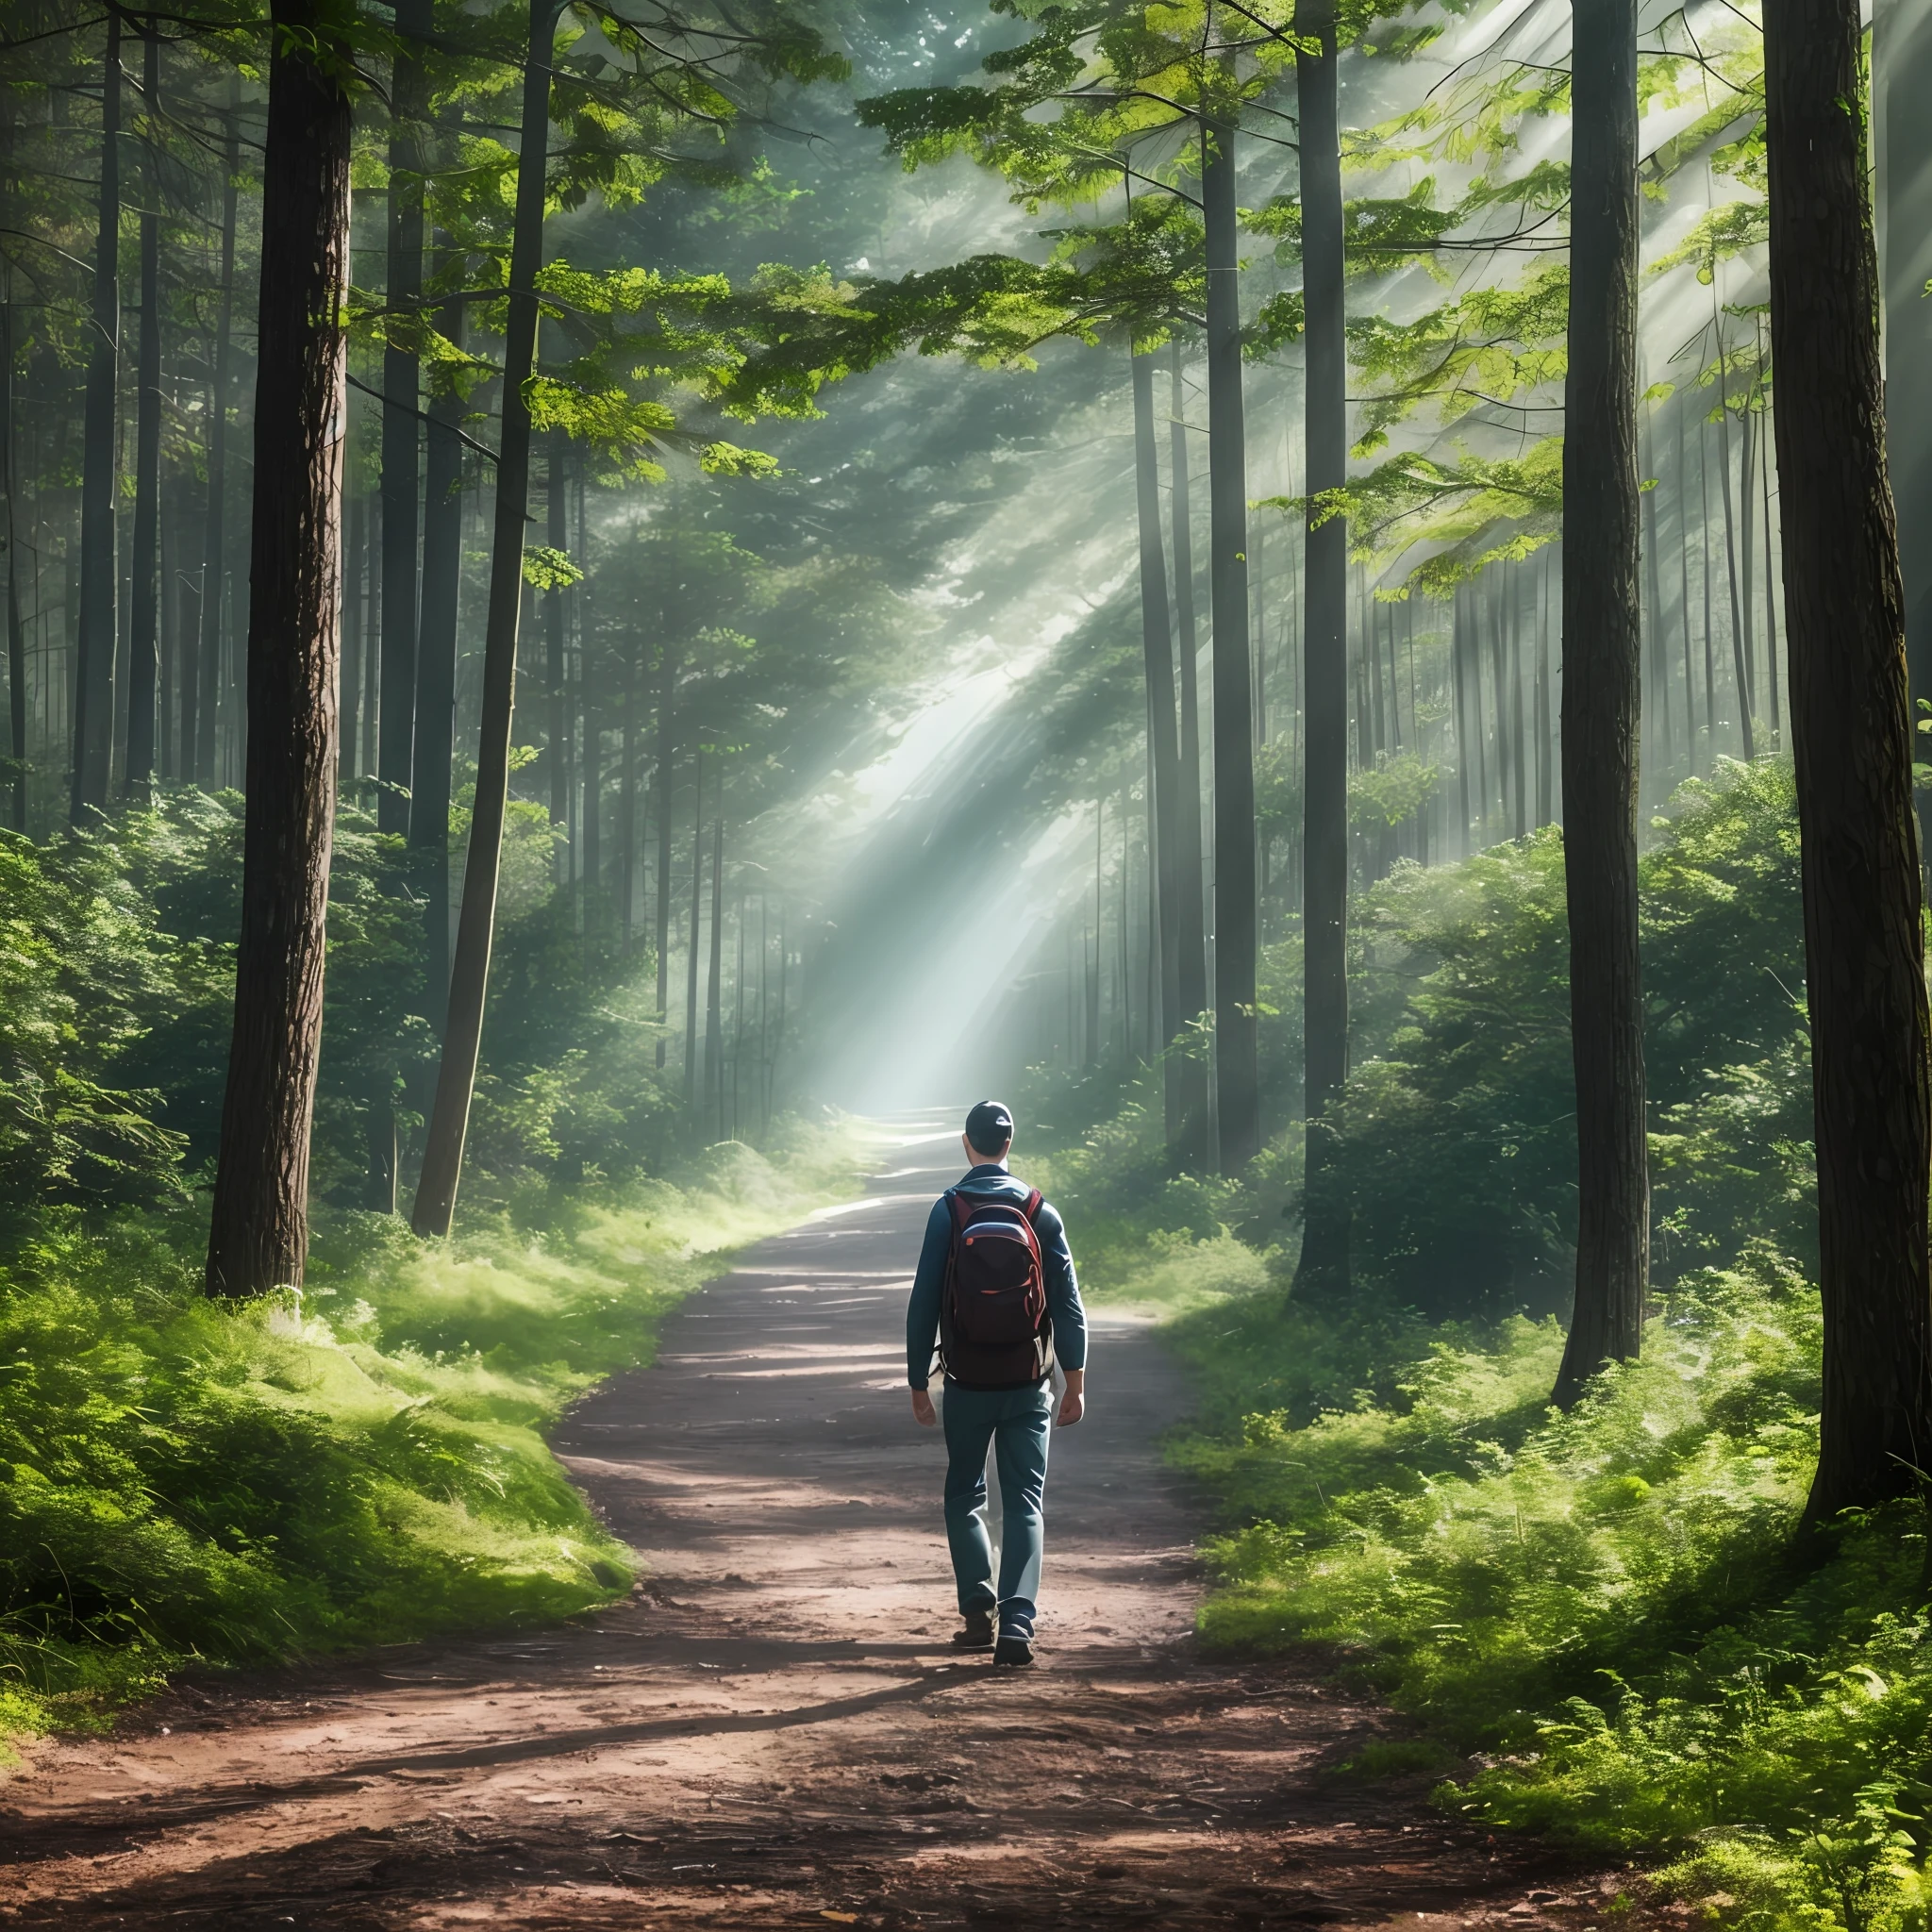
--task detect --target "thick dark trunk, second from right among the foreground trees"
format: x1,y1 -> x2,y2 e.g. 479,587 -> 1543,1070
1556,0 -> 1650,1408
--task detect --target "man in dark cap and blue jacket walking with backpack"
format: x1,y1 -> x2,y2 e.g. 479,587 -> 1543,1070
907,1099 -> 1086,1665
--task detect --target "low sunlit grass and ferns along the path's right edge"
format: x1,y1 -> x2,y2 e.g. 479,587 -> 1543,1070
1165,1250 -> 1932,1932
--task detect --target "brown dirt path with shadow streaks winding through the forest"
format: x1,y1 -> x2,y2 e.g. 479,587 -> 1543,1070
0,1121 -> 1681,1932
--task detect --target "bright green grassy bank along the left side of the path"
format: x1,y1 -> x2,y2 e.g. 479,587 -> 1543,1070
0,1124 -> 863,1769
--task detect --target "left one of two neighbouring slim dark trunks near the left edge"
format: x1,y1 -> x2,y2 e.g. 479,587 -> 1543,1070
68,6 -> 122,824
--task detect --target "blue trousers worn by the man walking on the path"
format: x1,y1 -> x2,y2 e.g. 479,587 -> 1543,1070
944,1381 -> 1053,1637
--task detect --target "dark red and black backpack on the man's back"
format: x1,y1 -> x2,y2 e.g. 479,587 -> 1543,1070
939,1189 -> 1053,1390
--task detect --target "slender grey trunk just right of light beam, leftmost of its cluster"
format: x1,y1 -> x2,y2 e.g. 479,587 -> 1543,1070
1130,354 -> 1189,1148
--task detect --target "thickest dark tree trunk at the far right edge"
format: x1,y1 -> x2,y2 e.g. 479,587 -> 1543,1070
1764,0 -> 1932,1524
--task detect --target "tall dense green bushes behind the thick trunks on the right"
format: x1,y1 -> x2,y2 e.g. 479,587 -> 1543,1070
1327,761 -> 1814,1316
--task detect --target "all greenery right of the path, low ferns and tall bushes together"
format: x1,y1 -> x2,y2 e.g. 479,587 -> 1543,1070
1041,759 -> 1932,1932
